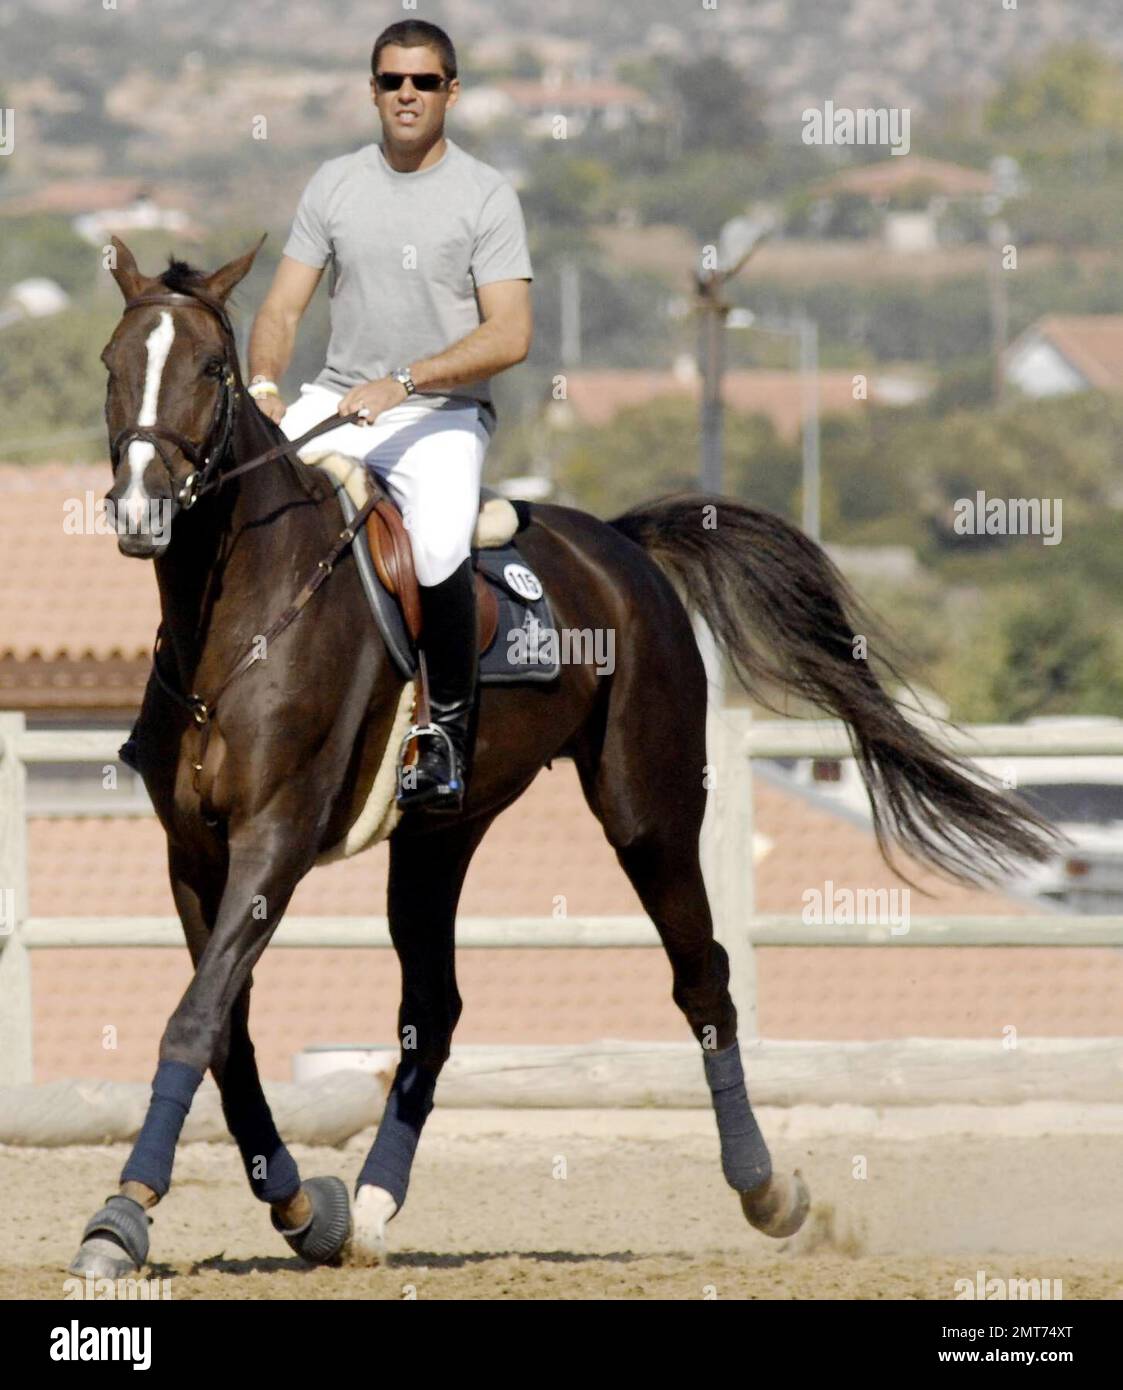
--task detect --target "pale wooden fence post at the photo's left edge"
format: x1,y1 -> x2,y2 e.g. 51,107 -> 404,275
0,712 -> 32,1086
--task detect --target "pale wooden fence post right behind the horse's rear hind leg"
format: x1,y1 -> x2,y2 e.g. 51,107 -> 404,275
702,706 -> 760,1041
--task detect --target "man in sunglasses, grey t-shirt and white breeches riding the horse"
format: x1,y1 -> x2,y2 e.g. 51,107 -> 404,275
126,19 -> 532,810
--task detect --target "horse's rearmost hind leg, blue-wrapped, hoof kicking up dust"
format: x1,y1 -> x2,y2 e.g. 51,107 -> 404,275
577,695 -> 809,1236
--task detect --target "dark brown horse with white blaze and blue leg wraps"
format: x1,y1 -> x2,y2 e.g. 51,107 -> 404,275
72,243 -> 1047,1275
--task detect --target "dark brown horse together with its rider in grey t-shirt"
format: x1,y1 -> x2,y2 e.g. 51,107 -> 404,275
69,13 -> 1054,1277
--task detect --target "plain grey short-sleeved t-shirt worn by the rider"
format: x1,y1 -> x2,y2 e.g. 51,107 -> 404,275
285,140 -> 532,432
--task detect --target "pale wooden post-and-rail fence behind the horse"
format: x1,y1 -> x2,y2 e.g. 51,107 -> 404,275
0,708 -> 1123,1104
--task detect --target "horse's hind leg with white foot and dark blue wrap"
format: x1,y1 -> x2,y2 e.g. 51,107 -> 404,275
347,816 -> 492,1265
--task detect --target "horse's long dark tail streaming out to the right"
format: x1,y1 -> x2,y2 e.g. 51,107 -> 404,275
612,493 -> 1056,881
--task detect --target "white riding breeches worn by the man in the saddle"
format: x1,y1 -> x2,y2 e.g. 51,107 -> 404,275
281,382 -> 489,585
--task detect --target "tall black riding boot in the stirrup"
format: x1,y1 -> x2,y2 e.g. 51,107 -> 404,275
397,560 -> 479,810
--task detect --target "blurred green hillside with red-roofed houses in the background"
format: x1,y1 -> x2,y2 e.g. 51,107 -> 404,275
0,8 -> 1123,719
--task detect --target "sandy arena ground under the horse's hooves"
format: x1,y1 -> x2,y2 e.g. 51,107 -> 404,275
0,1106 -> 1123,1300
